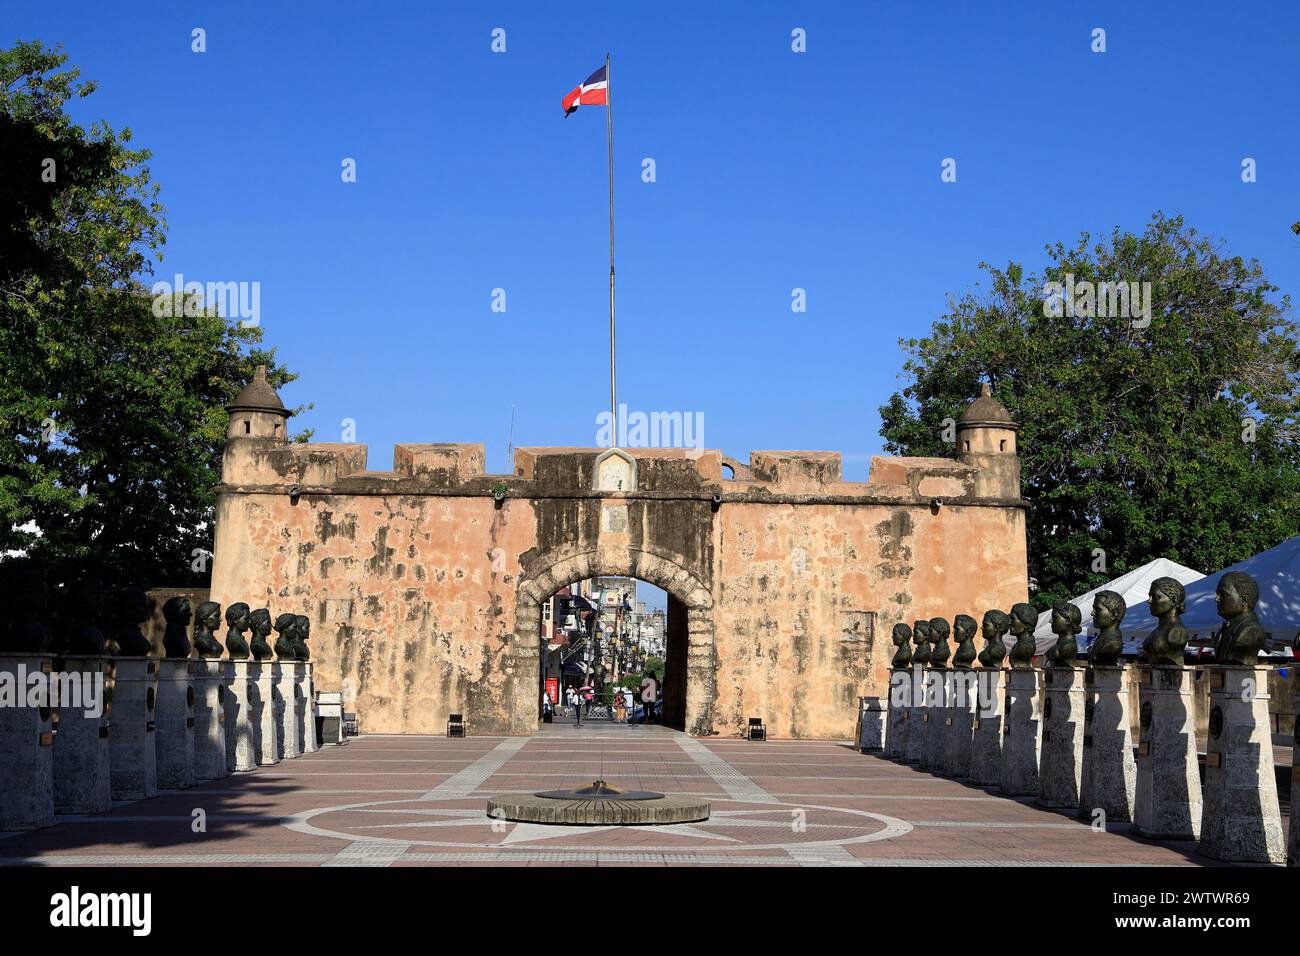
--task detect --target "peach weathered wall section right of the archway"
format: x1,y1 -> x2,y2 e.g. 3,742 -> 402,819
714,505 -> 1027,737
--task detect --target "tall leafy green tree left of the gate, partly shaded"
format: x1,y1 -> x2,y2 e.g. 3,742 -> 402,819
0,42 -> 306,585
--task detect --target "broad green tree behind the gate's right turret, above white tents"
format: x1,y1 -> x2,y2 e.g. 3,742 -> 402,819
880,213 -> 1300,607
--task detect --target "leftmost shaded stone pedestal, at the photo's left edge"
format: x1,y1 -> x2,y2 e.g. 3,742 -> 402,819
0,653 -> 55,830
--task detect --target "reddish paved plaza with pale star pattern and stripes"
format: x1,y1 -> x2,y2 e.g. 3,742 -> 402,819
0,723 -> 1287,866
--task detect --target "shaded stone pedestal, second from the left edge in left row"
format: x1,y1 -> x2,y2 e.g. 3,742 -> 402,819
55,656 -> 113,813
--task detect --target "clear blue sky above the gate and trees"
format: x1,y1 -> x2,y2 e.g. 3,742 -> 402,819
12,0 -> 1300,480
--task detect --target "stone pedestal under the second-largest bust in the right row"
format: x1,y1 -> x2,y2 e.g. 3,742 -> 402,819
1134,666 -> 1201,840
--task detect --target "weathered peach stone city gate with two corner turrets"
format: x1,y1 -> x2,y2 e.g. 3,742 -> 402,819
212,372 -> 1027,739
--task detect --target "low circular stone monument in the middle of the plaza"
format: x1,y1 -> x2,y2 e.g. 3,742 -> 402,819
488,780 -> 710,826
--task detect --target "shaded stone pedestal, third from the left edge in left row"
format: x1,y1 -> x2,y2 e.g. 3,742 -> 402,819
107,657 -> 159,800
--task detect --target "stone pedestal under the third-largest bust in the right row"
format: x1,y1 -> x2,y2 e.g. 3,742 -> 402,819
1079,666 -> 1138,823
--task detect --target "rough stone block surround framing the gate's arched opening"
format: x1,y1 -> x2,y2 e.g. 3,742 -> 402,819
515,549 -> 718,736
